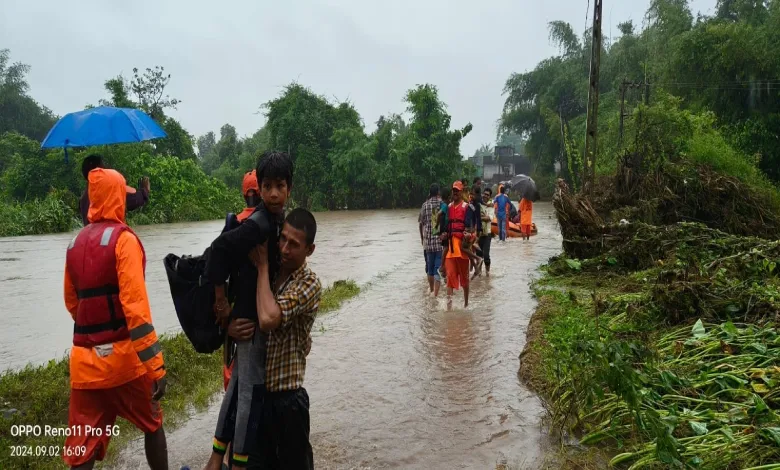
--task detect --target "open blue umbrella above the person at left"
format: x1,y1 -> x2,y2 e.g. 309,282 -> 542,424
41,106 -> 168,161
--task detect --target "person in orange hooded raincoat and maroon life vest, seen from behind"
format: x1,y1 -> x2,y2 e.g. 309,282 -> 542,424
63,168 -> 168,470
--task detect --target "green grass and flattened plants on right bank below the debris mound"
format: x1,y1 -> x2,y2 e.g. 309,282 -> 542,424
520,253 -> 780,469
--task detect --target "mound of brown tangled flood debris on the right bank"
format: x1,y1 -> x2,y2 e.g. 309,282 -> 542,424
553,162 -> 780,259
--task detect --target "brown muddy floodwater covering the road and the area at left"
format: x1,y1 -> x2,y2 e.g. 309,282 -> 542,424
0,203 -> 561,469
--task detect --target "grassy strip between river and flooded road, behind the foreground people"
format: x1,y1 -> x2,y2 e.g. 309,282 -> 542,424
0,281 -> 360,469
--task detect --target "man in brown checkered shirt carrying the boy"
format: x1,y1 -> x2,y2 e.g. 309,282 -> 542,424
252,209 -> 322,470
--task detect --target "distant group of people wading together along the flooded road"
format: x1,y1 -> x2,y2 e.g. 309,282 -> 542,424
418,177 -> 533,308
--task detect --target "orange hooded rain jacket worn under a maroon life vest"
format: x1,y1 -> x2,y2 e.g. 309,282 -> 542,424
65,168 -> 165,389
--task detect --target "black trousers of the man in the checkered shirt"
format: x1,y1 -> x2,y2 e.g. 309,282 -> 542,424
258,387 -> 314,470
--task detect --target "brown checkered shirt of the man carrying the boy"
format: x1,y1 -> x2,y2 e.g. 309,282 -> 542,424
265,263 -> 322,392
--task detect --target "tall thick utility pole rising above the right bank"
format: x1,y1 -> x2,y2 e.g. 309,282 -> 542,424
582,0 -> 602,192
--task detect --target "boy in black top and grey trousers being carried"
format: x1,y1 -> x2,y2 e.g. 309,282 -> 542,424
206,151 -> 293,470
